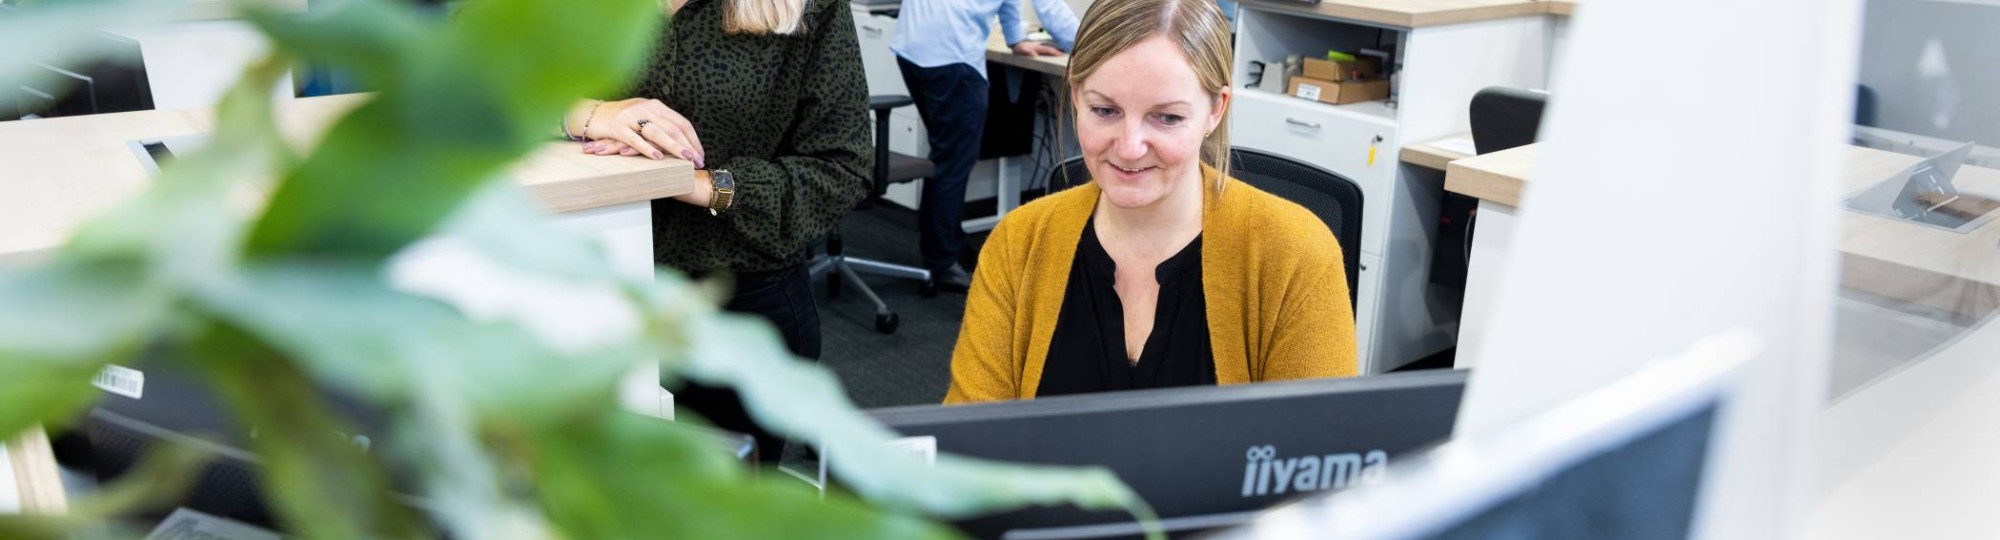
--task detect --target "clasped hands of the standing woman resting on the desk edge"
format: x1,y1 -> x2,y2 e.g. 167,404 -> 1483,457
582,98 -> 706,168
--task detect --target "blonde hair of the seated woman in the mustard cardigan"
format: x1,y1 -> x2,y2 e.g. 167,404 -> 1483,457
1064,0 -> 1236,192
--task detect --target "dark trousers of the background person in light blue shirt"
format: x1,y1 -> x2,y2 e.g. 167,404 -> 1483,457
896,56 -> 988,270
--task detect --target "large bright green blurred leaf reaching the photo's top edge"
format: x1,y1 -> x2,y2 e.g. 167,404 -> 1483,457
250,0 -> 662,258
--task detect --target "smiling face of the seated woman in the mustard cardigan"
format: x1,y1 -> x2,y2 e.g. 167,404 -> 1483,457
1070,36 -> 1228,208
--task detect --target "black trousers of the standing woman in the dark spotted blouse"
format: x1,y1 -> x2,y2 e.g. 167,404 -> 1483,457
674,266 -> 820,464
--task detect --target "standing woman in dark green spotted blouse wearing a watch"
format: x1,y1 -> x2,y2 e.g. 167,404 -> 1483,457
562,0 -> 874,460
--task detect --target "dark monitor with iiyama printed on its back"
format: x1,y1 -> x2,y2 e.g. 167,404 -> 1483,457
860,370 -> 1466,538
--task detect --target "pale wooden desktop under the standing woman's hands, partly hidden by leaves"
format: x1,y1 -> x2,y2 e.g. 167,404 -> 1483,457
0,94 -> 694,260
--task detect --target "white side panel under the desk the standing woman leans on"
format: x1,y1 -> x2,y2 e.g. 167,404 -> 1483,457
556,202 -> 674,420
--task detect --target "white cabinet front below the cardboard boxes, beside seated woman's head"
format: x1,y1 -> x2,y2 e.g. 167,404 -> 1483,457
1230,90 -> 1396,254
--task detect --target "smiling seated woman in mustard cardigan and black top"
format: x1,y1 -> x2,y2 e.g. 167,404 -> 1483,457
944,0 -> 1356,404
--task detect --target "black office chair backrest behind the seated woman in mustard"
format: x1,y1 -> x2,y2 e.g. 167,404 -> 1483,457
1048,148 -> 1362,308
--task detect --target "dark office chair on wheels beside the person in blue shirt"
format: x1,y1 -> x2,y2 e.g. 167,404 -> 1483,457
810,96 -> 938,334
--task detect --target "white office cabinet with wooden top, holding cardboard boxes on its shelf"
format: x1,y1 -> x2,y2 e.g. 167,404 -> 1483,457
1230,0 -> 1550,374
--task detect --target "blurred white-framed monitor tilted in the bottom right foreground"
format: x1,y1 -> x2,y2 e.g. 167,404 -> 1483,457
1220,348 -> 1738,540
